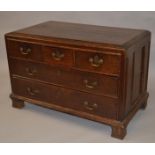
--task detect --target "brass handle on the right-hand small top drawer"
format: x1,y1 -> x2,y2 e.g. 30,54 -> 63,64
89,55 -> 103,67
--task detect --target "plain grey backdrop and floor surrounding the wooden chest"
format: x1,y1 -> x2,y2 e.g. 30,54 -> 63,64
0,12 -> 155,142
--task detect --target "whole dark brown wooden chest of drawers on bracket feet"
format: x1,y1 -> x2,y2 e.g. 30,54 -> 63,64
5,21 -> 150,139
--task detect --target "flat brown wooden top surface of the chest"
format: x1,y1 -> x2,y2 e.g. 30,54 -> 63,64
6,21 -> 150,47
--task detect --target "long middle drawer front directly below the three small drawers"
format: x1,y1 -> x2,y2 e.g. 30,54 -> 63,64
10,59 -> 119,98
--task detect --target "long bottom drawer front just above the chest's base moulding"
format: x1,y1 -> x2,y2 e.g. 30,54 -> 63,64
12,78 -> 117,119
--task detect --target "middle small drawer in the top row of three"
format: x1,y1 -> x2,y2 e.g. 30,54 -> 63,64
42,46 -> 73,67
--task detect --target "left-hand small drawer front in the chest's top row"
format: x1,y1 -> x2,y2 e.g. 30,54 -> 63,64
7,40 -> 42,61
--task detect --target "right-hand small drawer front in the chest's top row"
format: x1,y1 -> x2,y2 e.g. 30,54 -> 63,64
75,52 -> 121,75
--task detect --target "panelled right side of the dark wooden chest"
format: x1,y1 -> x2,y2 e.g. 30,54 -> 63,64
125,34 -> 150,115
